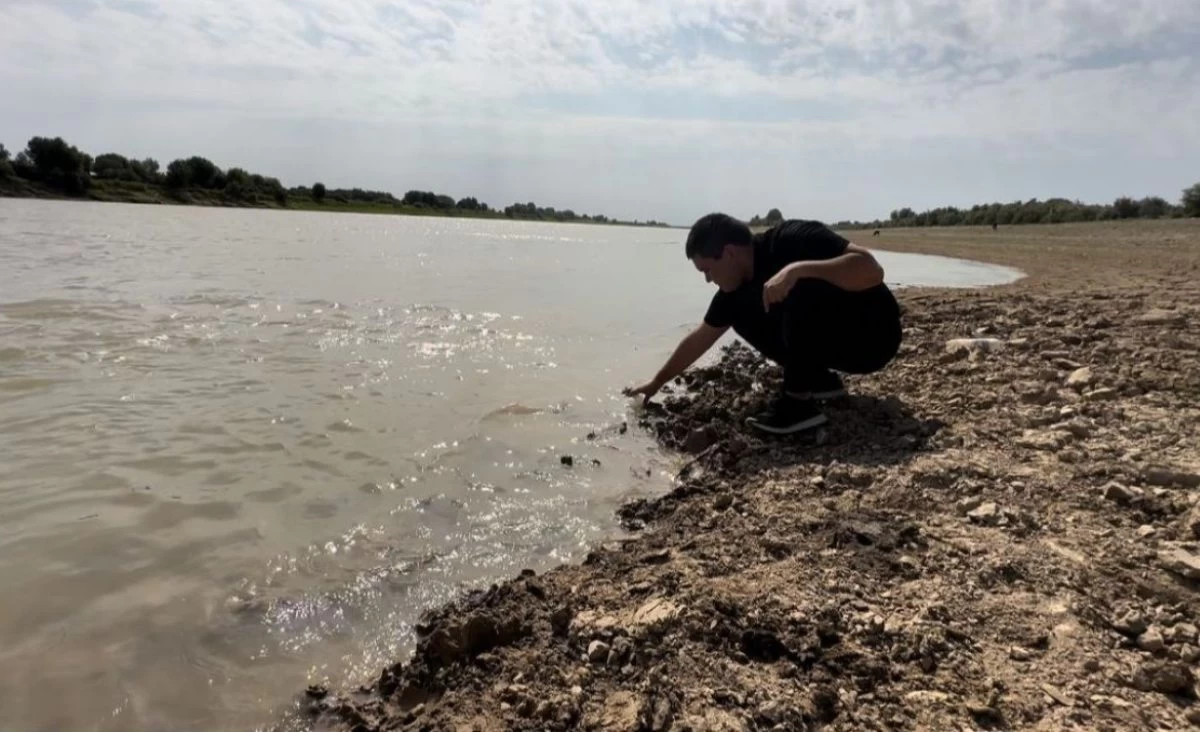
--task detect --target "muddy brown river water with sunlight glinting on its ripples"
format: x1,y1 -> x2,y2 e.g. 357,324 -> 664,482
0,200 -> 1019,730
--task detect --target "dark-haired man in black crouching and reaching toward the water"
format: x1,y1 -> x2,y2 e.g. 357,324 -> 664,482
625,214 -> 901,434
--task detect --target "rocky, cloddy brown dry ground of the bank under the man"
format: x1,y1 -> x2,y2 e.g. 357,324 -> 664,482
307,219 -> 1200,732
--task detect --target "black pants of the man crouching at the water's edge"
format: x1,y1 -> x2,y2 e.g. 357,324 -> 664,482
751,278 -> 902,394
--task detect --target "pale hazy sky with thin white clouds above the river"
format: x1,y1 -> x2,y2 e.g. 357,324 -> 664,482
0,0 -> 1200,224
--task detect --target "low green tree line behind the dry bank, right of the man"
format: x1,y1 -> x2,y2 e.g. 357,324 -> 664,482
836,184 -> 1200,228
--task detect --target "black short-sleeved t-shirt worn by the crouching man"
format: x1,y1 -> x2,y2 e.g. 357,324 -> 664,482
704,220 -> 896,359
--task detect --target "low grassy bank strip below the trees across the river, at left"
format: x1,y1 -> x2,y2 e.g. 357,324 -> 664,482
0,178 -> 678,228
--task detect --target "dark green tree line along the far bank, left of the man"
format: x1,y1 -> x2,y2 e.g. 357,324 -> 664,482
0,137 -> 667,227
